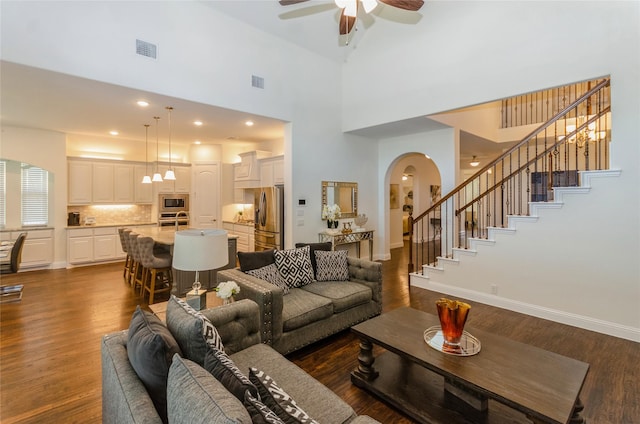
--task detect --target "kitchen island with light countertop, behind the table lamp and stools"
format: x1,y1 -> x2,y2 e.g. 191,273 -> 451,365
136,227 -> 238,297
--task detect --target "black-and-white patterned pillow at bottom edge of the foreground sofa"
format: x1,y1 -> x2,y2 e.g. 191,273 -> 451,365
249,367 -> 318,424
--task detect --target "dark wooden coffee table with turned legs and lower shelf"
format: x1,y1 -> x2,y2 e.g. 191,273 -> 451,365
351,307 -> 589,424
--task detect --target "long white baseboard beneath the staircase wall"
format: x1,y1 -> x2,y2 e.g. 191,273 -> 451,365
410,278 -> 640,342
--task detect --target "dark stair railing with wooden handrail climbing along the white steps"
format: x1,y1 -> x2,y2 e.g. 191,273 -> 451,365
408,78 -> 611,274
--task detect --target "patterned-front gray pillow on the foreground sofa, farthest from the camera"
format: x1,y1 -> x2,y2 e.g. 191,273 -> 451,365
167,295 -> 224,366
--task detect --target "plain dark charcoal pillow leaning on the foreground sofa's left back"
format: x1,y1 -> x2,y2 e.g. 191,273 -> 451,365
127,306 -> 182,423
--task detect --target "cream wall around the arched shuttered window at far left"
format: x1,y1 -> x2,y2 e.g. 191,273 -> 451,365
0,127 -> 67,268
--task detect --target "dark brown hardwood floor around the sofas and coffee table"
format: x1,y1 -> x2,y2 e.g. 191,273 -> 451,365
0,248 -> 640,424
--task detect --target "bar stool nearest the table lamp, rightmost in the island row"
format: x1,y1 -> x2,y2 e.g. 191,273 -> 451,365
138,237 -> 173,305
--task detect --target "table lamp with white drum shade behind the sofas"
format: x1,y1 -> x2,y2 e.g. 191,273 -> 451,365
173,229 -> 229,310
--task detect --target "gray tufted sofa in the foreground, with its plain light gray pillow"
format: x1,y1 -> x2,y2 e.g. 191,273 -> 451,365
101,300 -> 377,424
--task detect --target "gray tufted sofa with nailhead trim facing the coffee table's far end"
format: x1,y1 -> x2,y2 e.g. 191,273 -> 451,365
218,257 -> 382,355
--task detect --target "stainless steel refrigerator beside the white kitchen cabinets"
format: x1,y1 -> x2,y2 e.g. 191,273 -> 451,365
254,186 -> 284,252
